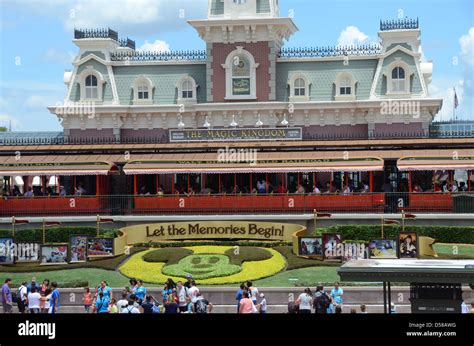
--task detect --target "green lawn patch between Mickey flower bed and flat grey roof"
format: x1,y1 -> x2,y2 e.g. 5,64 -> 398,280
254,266 -> 340,288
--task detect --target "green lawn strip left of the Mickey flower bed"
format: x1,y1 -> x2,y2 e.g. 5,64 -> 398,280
0,268 -> 129,288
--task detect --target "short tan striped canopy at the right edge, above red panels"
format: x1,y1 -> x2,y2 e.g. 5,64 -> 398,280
397,157 -> 474,171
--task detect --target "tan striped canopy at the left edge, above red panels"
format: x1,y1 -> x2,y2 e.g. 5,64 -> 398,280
0,155 -> 117,176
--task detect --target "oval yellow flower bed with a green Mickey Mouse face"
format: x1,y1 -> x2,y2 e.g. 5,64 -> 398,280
119,246 -> 287,285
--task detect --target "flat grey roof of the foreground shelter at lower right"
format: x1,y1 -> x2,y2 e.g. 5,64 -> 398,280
338,259 -> 474,284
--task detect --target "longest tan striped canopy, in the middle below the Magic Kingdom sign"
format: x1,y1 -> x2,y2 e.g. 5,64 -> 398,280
124,152 -> 384,175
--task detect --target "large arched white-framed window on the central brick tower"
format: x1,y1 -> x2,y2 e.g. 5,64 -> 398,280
222,47 -> 259,100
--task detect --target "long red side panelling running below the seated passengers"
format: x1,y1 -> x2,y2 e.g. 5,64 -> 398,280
0,192 -> 474,217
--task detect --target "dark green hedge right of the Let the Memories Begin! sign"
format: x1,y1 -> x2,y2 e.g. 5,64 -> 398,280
313,225 -> 474,244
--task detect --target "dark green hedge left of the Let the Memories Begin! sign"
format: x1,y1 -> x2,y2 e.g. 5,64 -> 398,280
0,226 -> 119,243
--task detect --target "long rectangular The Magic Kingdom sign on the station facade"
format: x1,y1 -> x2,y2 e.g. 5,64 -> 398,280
170,127 -> 302,142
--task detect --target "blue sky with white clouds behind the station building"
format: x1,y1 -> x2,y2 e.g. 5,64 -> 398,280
0,0 -> 474,131
